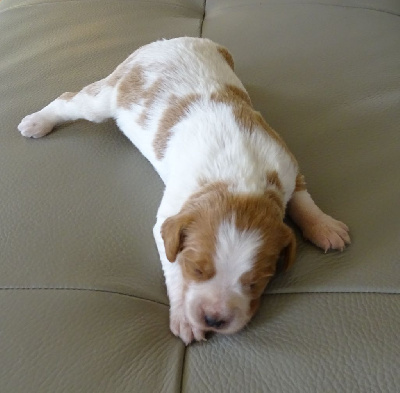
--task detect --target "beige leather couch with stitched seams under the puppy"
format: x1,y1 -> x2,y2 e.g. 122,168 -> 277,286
0,0 -> 400,393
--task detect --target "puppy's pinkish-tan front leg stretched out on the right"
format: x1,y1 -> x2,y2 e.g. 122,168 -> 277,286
288,190 -> 350,252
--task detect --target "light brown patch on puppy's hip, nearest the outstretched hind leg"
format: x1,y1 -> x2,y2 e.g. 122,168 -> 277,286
117,65 -> 144,109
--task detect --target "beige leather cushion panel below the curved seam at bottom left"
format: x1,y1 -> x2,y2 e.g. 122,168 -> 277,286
0,290 -> 184,393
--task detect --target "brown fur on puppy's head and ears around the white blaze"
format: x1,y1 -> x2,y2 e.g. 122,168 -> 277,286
161,182 -> 296,286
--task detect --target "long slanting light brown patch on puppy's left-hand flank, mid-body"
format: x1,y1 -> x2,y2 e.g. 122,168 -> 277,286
153,94 -> 200,160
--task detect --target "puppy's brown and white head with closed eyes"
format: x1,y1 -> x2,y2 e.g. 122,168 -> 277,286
161,187 -> 296,334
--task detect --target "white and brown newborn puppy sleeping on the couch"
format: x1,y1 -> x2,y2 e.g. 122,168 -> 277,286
18,37 -> 350,344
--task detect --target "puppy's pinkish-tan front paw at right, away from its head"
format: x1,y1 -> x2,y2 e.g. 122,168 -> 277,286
303,214 -> 351,252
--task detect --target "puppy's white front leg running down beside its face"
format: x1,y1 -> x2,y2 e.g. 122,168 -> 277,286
153,219 -> 205,345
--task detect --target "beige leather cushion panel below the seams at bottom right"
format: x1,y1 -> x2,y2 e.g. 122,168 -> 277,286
183,294 -> 400,393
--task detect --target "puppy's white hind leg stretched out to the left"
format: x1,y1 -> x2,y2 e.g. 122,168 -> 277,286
18,79 -> 113,138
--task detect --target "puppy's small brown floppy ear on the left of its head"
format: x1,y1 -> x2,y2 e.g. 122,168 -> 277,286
161,213 -> 192,262
